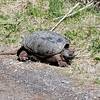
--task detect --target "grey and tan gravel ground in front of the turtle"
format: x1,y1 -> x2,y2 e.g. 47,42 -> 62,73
0,56 -> 100,100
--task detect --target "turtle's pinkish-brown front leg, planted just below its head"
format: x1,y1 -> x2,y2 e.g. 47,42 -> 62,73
54,54 -> 68,67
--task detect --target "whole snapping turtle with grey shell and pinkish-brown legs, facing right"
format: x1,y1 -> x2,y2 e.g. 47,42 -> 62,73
17,31 -> 74,66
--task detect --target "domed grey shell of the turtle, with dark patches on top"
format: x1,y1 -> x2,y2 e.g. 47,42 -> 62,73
22,31 -> 70,57
